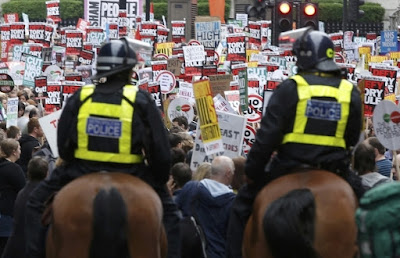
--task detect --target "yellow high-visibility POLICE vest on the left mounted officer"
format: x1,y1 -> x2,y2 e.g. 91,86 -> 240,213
75,85 -> 143,164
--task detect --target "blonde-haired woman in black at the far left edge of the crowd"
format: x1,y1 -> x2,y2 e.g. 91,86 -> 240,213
0,138 -> 25,256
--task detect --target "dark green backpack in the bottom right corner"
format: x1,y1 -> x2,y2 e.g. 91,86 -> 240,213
356,182 -> 400,258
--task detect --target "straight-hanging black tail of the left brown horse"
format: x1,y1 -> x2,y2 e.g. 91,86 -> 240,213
89,187 -> 129,258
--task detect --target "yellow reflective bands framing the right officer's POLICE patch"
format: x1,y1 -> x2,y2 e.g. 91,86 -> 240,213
283,75 -> 353,148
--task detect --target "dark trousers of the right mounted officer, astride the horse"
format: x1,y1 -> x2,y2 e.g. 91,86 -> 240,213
226,166 -> 365,258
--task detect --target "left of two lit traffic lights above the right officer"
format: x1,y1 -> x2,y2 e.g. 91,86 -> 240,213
272,0 -> 293,45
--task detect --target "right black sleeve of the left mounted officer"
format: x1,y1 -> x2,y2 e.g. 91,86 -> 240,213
135,90 -> 171,184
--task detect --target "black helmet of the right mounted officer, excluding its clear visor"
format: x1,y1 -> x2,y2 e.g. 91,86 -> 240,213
293,30 -> 340,72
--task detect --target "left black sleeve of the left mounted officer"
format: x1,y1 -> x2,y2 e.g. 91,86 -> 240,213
57,90 -> 80,162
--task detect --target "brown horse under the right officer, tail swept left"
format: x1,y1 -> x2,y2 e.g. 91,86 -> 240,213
243,170 -> 358,258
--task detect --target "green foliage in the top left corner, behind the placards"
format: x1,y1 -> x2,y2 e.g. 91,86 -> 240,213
1,0 -> 83,19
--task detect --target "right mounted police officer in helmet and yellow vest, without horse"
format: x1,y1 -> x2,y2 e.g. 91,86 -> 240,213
227,28 -> 363,257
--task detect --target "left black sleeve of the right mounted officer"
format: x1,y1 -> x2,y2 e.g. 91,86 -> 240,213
245,79 -> 297,180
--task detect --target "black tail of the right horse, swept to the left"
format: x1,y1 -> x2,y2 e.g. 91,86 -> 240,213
263,188 -> 319,258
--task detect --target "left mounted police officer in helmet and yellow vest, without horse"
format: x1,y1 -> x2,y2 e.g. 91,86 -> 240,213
26,38 -> 180,258
